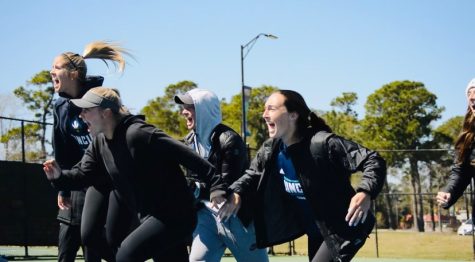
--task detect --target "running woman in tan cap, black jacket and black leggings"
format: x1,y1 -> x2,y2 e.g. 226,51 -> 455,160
43,87 -> 221,262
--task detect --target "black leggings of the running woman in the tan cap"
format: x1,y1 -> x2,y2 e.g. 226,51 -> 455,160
81,189 -> 193,262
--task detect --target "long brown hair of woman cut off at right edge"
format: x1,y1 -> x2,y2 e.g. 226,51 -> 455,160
455,106 -> 475,163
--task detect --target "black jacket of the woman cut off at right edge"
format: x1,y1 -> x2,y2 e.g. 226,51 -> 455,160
442,145 -> 475,217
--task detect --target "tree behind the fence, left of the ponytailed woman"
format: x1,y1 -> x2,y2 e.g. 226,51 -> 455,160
1,70 -> 54,161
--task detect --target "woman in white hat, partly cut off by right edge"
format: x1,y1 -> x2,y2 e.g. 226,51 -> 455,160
436,78 -> 475,227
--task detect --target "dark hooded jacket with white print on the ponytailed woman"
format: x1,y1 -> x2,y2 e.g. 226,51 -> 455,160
52,76 -> 104,225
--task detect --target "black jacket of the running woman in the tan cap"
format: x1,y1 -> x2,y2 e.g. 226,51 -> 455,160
53,115 -> 224,227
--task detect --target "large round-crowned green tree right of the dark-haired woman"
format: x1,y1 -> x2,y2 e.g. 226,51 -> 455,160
362,81 -> 444,232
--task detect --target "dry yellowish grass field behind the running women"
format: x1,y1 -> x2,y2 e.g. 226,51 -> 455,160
0,230 -> 473,262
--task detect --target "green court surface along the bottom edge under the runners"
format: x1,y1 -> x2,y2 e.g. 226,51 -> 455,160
0,246 -> 470,262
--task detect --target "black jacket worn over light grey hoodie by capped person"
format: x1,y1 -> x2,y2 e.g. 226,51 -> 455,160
185,124 -> 253,226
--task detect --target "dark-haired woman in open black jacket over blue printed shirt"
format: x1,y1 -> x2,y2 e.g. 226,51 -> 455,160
219,90 -> 386,262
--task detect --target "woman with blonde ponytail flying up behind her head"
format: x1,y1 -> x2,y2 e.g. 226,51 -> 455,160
50,41 -> 130,262
